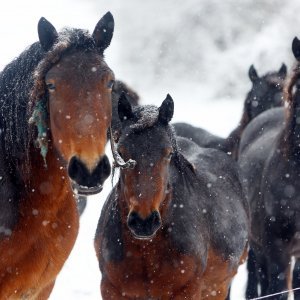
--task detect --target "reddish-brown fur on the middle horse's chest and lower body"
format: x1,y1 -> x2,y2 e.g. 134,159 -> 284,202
95,184 -> 248,300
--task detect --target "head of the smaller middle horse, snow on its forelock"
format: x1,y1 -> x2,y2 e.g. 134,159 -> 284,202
118,94 -> 174,239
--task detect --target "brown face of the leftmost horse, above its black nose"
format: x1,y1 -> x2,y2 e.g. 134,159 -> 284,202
45,52 -> 114,171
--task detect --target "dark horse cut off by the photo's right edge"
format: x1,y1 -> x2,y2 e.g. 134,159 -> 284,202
238,38 -> 300,300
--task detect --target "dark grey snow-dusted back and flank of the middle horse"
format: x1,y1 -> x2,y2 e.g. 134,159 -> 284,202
173,138 -> 249,261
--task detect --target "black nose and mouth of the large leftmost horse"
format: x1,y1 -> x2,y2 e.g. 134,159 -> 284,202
68,155 -> 111,195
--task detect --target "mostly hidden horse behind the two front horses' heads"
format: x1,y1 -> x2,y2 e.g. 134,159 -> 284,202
77,80 -> 140,215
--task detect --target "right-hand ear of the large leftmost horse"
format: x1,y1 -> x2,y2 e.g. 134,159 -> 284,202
93,12 -> 115,52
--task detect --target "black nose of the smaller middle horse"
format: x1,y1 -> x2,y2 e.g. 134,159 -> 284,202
127,211 -> 161,239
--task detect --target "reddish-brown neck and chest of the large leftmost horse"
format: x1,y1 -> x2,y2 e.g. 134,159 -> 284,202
0,147 -> 78,299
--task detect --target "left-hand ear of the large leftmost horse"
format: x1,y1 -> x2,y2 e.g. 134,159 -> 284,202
38,17 -> 58,51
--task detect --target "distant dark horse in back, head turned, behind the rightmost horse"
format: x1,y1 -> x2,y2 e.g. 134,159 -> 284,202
173,64 -> 287,160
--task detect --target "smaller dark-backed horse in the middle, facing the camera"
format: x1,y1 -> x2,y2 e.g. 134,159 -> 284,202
95,94 -> 248,300
